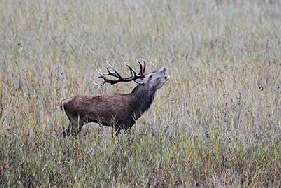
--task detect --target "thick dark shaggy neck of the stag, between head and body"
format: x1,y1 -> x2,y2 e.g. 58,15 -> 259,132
130,85 -> 157,119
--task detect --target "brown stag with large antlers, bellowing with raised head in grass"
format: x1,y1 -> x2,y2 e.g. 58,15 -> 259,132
61,62 -> 170,136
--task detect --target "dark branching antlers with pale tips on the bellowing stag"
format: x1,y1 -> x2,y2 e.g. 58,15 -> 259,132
98,61 -> 145,86
